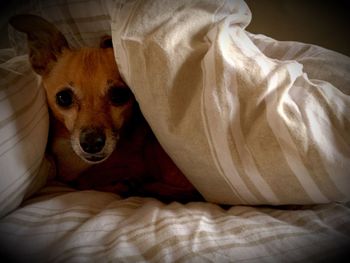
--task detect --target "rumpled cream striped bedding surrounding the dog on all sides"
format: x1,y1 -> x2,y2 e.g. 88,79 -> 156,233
0,0 -> 350,262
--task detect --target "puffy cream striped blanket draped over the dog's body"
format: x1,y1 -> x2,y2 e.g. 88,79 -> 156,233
112,0 -> 350,204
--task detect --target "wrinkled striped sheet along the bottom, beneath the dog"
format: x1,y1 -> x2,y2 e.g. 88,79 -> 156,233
0,186 -> 350,262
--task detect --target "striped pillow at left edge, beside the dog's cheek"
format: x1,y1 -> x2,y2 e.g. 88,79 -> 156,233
0,52 -> 51,216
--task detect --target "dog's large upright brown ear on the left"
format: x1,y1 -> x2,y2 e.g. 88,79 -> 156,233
9,15 -> 69,75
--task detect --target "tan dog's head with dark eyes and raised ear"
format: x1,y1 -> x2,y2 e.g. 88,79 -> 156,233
10,15 -> 134,163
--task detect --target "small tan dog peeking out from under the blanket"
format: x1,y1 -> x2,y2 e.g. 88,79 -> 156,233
10,15 -> 202,202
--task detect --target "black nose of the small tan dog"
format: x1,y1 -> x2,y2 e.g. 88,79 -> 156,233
79,128 -> 106,154
